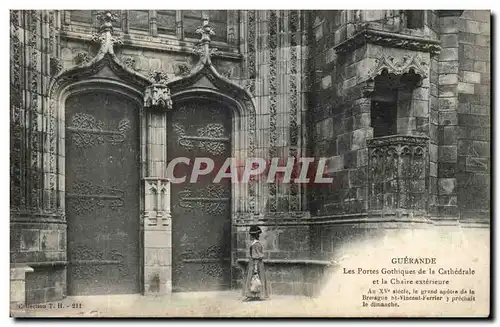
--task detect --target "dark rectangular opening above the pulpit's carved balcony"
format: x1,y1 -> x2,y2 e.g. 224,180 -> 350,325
371,100 -> 398,137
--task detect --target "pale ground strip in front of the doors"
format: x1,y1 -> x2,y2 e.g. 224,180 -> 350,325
11,292 -> 332,317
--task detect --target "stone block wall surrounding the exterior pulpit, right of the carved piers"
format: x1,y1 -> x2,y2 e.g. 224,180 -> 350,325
309,10 -> 490,272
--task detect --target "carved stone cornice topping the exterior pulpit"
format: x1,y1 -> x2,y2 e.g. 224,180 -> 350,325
334,28 -> 441,55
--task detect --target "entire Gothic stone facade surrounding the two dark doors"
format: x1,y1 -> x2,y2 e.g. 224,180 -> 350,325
10,10 -> 491,303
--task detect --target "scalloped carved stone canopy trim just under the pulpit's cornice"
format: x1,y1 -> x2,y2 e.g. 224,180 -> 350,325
368,54 -> 428,78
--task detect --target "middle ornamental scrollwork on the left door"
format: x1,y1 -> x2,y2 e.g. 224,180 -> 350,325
66,181 -> 124,215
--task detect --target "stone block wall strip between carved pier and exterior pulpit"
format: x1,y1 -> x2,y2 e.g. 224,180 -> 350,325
309,11 -> 372,215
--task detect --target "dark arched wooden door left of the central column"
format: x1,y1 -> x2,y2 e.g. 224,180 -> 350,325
65,92 -> 140,295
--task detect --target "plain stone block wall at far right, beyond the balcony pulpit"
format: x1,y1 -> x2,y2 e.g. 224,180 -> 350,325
431,10 -> 491,226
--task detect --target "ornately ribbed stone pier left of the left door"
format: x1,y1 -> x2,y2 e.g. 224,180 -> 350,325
10,10 -> 66,303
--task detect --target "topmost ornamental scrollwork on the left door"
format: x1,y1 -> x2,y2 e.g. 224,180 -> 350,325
66,113 -> 130,149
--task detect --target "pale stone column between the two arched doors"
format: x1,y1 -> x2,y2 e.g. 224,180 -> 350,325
143,76 -> 172,296
